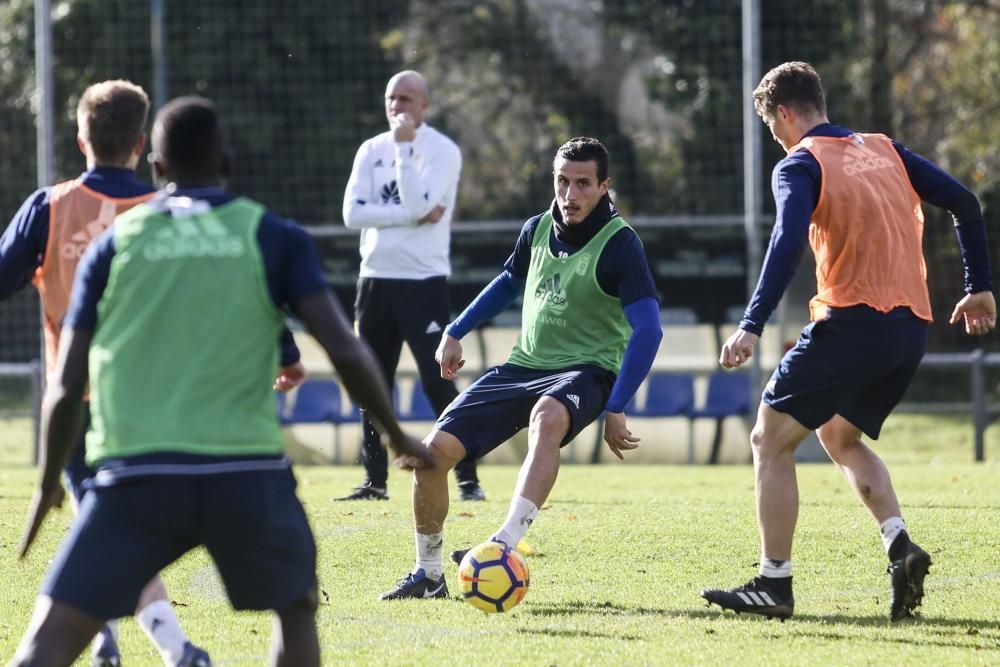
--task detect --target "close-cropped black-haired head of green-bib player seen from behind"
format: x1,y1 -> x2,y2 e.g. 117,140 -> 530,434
153,96 -> 226,179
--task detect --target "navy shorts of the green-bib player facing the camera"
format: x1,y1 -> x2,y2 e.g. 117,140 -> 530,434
435,364 -> 615,458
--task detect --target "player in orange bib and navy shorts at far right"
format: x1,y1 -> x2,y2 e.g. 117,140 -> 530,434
702,62 -> 996,621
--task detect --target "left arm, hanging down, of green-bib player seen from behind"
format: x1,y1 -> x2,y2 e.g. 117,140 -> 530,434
20,228 -> 115,558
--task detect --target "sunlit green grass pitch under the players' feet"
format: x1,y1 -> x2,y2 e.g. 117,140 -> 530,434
0,417 -> 1000,667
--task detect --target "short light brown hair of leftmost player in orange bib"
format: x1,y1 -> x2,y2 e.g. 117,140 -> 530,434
76,79 -> 149,166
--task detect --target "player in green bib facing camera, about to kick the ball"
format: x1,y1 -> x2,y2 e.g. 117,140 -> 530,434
382,137 -> 663,600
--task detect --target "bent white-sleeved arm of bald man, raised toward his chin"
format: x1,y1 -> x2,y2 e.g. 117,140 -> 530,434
396,142 -> 462,222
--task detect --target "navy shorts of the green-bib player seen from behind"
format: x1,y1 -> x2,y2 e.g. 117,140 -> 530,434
41,470 -> 316,620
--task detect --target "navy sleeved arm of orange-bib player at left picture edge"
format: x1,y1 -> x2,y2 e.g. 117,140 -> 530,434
0,188 -> 51,301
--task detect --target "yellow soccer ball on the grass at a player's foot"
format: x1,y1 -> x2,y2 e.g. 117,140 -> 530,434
458,542 -> 528,614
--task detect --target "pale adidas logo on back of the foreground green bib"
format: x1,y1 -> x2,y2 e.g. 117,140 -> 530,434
142,215 -> 245,262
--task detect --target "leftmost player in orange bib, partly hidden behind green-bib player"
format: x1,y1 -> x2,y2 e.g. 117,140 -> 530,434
0,80 -> 215,667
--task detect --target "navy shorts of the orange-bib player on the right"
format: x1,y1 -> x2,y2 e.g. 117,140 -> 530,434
762,316 -> 928,439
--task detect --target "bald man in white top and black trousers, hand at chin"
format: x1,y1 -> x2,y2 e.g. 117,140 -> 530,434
338,70 -> 486,500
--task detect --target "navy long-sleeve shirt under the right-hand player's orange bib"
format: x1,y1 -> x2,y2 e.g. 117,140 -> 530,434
739,123 -> 993,335
